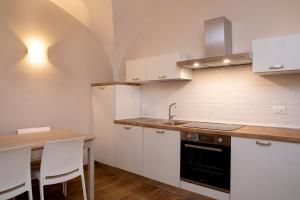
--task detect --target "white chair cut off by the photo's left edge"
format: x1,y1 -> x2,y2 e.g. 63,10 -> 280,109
0,145 -> 32,200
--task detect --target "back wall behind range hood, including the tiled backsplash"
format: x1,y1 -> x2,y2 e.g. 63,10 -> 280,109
120,0 -> 300,128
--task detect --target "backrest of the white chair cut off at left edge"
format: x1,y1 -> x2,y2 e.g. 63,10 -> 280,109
0,145 -> 31,192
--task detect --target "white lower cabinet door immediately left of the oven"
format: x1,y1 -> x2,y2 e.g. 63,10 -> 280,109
144,128 -> 180,187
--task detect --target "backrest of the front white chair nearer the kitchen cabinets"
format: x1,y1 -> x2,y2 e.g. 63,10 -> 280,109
41,137 -> 84,178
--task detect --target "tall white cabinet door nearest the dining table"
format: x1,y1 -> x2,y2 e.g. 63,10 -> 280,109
92,85 -> 115,166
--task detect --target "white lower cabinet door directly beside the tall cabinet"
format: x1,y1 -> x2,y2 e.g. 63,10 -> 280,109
115,125 -> 143,175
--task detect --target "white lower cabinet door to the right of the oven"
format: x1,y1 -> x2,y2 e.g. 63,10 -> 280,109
230,137 -> 300,200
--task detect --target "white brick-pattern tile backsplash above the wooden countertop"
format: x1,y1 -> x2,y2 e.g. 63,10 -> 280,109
141,66 -> 300,128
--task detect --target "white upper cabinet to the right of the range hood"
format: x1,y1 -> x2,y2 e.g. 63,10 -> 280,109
252,33 -> 300,74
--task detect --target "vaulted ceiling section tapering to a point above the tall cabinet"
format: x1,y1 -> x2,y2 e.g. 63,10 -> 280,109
50,0 -> 159,77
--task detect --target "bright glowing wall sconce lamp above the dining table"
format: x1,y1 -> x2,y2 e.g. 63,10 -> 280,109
26,39 -> 47,65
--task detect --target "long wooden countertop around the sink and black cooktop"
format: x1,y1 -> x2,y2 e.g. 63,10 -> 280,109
114,118 -> 300,143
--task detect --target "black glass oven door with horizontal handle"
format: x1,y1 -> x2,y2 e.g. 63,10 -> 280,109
180,140 -> 230,192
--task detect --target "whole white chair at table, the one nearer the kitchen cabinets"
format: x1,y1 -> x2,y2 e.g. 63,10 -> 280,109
33,138 -> 87,200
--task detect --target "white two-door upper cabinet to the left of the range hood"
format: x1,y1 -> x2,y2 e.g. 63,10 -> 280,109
126,53 -> 192,82
